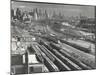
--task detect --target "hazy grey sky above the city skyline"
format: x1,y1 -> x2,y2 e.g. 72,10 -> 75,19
12,2 -> 95,18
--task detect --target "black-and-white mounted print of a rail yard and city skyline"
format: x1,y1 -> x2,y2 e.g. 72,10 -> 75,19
10,0 -> 96,75
